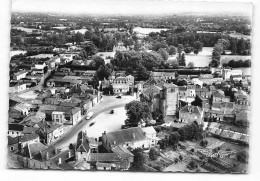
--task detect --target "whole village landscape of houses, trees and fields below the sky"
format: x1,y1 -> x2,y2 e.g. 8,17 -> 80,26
6,0 -> 252,173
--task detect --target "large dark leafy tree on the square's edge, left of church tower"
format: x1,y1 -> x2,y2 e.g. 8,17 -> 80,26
125,101 -> 152,126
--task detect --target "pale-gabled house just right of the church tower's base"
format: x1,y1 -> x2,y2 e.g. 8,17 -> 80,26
179,105 -> 204,125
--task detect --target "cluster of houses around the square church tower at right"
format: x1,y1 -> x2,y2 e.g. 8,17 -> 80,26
140,69 -> 250,144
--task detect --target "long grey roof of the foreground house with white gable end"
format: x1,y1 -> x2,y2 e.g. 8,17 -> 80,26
106,127 -> 146,145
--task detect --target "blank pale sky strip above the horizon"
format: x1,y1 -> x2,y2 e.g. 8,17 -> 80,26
12,0 -> 252,15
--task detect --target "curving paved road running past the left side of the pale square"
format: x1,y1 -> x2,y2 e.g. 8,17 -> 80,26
50,96 -> 135,148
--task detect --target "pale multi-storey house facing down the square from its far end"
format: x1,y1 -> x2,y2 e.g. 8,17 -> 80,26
112,77 -> 130,94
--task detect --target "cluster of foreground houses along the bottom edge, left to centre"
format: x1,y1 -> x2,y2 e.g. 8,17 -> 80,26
8,125 -> 160,170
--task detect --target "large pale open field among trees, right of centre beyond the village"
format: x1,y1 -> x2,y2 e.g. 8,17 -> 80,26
185,47 -> 213,67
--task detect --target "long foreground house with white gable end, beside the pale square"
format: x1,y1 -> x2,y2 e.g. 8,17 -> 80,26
102,127 -> 150,152
